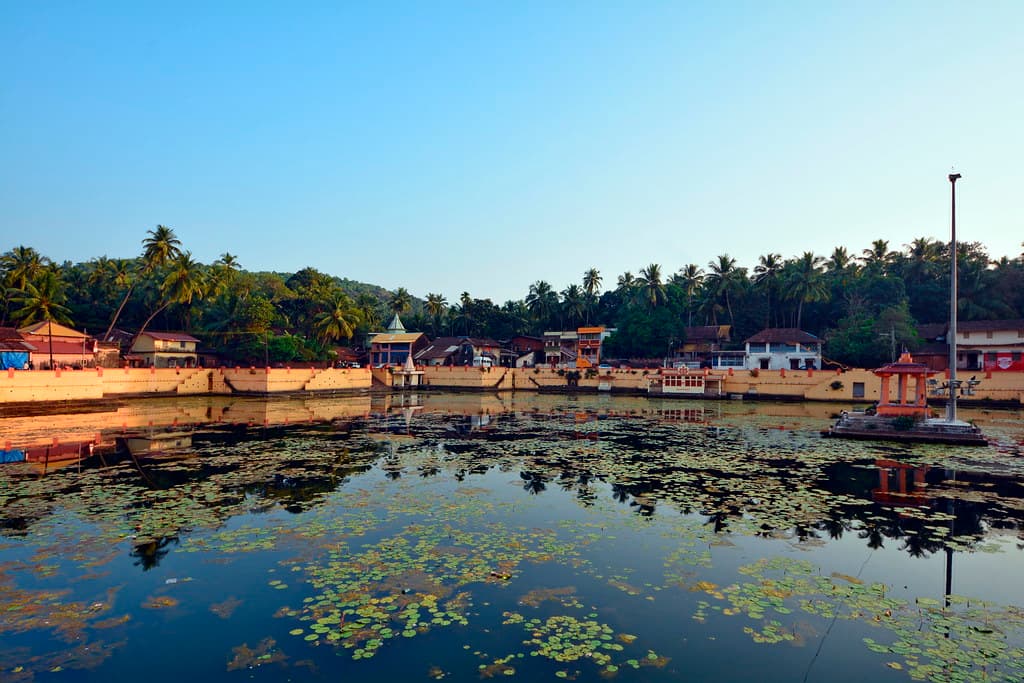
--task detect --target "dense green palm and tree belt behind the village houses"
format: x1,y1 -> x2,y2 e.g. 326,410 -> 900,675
0,225 -> 1024,367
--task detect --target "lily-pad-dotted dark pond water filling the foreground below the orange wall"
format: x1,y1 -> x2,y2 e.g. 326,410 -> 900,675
0,393 -> 1024,683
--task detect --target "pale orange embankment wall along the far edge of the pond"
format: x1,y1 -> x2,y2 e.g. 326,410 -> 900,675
0,367 -> 1024,404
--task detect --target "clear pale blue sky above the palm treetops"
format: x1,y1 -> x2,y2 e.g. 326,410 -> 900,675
0,0 -> 1024,303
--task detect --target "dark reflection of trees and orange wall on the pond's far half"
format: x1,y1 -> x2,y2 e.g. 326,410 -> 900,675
2,393 -> 1024,562
